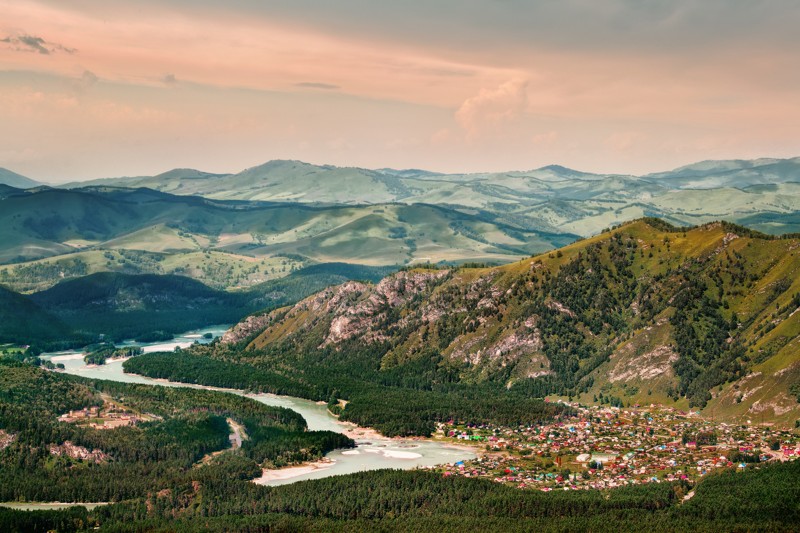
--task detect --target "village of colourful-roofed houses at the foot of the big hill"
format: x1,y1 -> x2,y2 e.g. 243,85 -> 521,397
437,404 -> 800,491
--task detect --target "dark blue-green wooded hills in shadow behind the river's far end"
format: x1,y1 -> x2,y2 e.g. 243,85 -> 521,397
0,263 -> 394,351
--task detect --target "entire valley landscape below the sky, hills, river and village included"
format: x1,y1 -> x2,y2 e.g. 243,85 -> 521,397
0,160 -> 800,531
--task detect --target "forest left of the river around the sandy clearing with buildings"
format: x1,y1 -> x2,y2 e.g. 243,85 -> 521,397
0,360 -> 353,502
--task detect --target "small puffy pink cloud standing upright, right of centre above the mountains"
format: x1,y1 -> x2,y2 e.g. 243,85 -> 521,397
455,80 -> 528,139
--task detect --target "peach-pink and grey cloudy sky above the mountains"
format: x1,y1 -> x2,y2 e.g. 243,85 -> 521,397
0,0 -> 800,183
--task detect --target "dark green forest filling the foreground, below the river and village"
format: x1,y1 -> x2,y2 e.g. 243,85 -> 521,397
0,358 -> 800,533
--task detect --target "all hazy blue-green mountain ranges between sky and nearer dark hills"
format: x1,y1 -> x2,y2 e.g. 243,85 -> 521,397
0,154 -> 800,291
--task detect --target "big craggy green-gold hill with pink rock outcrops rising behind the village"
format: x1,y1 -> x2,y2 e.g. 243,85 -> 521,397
225,219 -> 800,421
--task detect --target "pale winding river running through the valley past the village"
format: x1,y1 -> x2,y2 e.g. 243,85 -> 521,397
42,325 -> 475,486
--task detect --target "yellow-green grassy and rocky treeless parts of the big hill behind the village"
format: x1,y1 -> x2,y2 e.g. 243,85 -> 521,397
244,221 -> 800,422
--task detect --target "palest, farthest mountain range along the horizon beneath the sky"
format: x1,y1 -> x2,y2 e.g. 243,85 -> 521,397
61,158 -> 800,237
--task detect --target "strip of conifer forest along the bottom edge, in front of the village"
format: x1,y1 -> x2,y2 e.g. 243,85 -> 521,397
0,462 -> 800,532
